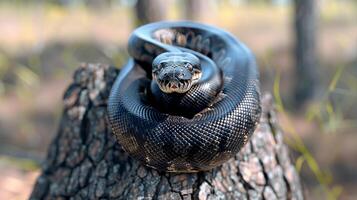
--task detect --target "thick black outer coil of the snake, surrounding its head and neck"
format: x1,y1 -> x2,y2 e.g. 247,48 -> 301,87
108,22 -> 261,172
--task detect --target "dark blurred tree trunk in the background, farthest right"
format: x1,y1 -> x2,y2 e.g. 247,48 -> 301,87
294,0 -> 319,107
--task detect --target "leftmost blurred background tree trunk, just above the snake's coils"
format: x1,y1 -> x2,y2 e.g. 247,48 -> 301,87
135,0 -> 167,26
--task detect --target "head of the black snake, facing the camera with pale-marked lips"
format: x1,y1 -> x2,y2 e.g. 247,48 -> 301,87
152,52 -> 202,93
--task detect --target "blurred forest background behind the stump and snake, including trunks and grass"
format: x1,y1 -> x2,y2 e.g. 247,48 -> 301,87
0,0 -> 357,199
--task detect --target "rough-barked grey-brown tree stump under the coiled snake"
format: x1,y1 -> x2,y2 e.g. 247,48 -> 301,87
30,64 -> 303,200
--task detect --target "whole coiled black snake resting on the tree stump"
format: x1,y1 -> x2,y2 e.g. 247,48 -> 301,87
108,21 -> 261,172
